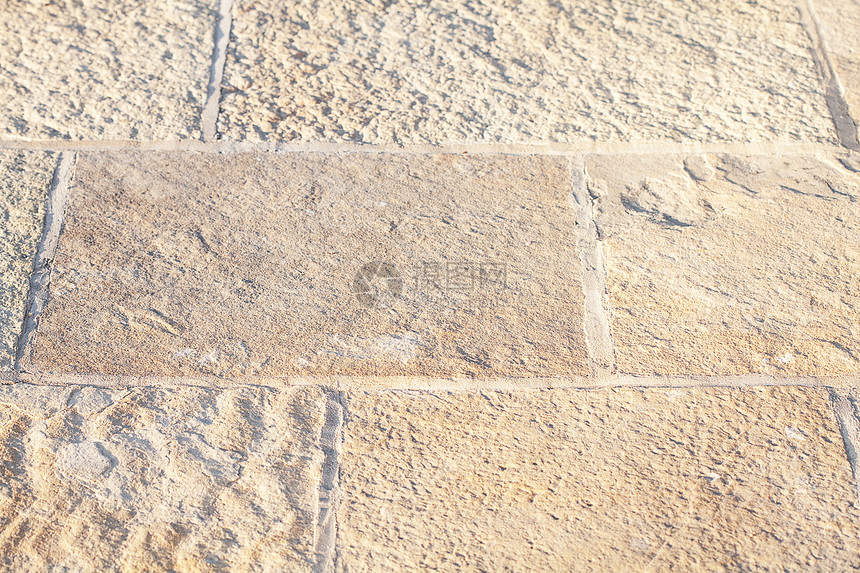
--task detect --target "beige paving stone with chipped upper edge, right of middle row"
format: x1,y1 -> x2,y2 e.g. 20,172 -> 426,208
587,155 -> 860,375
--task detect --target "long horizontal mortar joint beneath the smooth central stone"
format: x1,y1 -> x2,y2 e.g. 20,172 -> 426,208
11,371 -> 860,392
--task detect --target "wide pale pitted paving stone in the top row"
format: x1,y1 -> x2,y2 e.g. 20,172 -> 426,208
219,0 -> 836,144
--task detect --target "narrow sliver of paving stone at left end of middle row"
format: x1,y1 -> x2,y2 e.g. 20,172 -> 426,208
0,151 -> 57,370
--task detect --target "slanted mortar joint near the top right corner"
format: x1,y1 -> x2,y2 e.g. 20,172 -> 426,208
798,0 -> 860,150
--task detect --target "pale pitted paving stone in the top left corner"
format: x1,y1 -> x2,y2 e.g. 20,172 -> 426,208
0,0 -> 217,140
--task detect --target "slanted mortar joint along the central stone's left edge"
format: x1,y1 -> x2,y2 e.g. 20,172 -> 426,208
15,153 -> 76,372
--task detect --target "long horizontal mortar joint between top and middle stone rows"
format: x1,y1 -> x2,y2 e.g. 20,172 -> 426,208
0,139 -> 845,157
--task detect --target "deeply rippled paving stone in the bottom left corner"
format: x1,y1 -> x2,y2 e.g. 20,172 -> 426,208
0,384 -> 324,572
